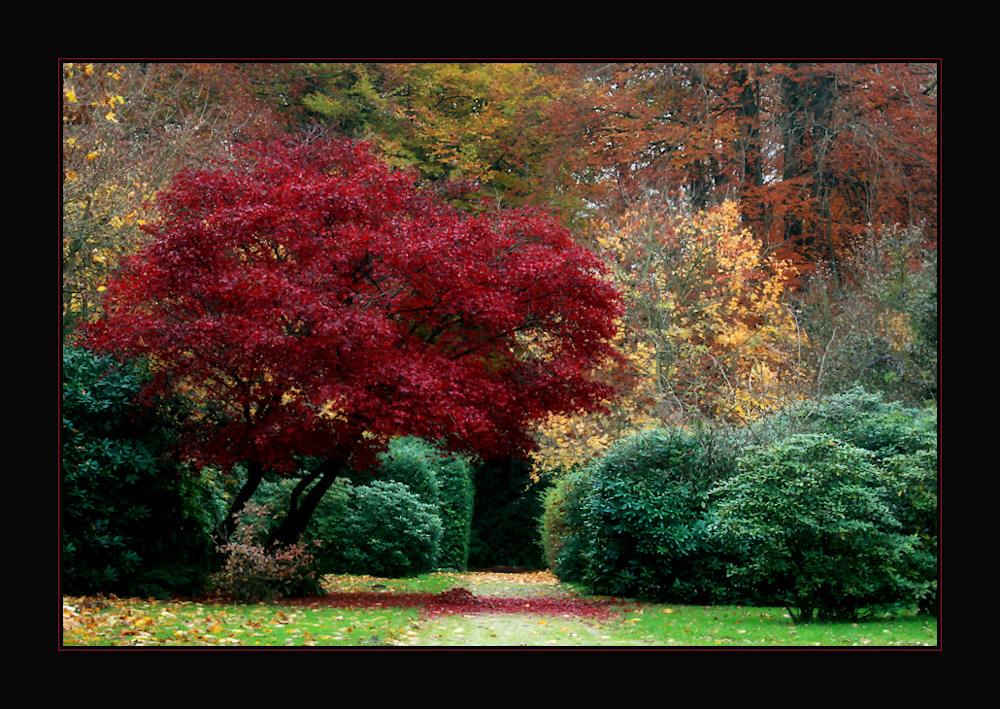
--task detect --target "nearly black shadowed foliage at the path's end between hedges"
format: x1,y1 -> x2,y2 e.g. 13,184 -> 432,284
469,458 -> 546,569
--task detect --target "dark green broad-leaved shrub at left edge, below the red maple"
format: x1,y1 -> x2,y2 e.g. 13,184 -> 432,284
60,349 -> 211,596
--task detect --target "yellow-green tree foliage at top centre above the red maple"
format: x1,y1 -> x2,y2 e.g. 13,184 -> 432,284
243,62 -> 576,214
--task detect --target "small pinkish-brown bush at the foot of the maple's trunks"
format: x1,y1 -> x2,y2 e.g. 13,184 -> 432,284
212,500 -> 316,603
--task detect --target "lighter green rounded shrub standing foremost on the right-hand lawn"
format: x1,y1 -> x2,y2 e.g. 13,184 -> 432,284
713,434 -> 916,622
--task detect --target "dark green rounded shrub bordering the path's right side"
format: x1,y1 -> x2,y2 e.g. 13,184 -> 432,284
576,430 -> 752,603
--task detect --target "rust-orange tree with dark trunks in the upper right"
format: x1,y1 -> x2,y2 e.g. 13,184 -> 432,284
558,62 -> 938,266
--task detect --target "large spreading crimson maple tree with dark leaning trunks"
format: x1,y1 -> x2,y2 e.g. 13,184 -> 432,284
86,140 -> 620,543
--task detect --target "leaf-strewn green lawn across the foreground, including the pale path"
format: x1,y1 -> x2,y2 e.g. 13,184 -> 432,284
62,573 -> 938,649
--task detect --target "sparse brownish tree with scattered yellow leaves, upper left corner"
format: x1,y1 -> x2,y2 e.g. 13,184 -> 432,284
59,62 -> 286,336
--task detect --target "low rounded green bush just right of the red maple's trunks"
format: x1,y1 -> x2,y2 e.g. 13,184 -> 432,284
331,480 -> 441,577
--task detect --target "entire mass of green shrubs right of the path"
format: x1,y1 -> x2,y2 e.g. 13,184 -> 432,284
541,389 -> 938,620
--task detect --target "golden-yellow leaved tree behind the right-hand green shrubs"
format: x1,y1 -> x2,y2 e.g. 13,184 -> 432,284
535,202 -> 806,472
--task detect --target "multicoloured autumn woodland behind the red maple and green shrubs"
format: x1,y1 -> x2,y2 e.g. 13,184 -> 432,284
59,61 -> 939,612
